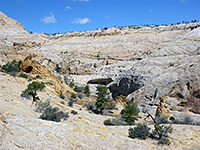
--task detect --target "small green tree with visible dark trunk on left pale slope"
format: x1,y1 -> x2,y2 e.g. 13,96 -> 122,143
22,81 -> 45,102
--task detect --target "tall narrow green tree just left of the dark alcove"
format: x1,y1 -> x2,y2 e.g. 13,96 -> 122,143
95,86 -> 108,112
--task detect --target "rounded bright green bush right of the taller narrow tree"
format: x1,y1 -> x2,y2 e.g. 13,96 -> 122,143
121,102 -> 138,125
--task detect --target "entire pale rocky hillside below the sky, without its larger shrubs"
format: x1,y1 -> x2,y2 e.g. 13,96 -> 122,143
0,12 -> 200,150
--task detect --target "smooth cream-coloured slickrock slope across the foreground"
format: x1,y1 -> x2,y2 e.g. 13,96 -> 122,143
0,72 -> 200,150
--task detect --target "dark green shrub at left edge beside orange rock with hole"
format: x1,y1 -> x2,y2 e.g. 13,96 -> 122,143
2,60 -> 22,75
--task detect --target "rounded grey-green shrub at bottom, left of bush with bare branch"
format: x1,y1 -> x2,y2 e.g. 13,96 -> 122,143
128,124 -> 150,140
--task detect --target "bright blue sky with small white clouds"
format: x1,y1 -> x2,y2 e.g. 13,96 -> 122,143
0,0 -> 200,33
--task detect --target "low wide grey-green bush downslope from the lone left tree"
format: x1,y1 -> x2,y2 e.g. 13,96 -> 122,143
40,106 -> 69,122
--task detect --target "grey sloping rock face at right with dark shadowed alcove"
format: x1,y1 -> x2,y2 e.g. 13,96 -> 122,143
110,28 -> 200,112
